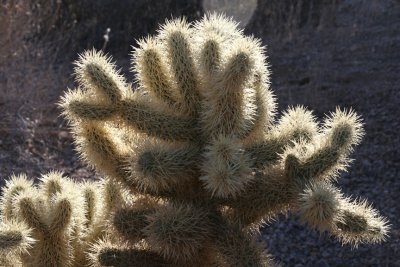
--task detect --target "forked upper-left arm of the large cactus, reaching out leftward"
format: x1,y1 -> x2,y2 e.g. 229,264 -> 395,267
60,52 -> 196,143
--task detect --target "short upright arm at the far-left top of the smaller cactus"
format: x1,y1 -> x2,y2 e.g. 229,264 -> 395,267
0,174 -> 33,220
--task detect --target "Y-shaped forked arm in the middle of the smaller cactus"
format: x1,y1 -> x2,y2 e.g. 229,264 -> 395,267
19,187 -> 84,267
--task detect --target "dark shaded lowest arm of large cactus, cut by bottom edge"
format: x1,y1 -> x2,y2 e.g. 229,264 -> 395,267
89,240 -> 174,267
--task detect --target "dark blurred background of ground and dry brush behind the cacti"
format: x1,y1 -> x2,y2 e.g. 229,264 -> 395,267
0,0 -> 400,267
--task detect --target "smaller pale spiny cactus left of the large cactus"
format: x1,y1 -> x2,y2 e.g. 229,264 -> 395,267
0,172 -> 119,267
